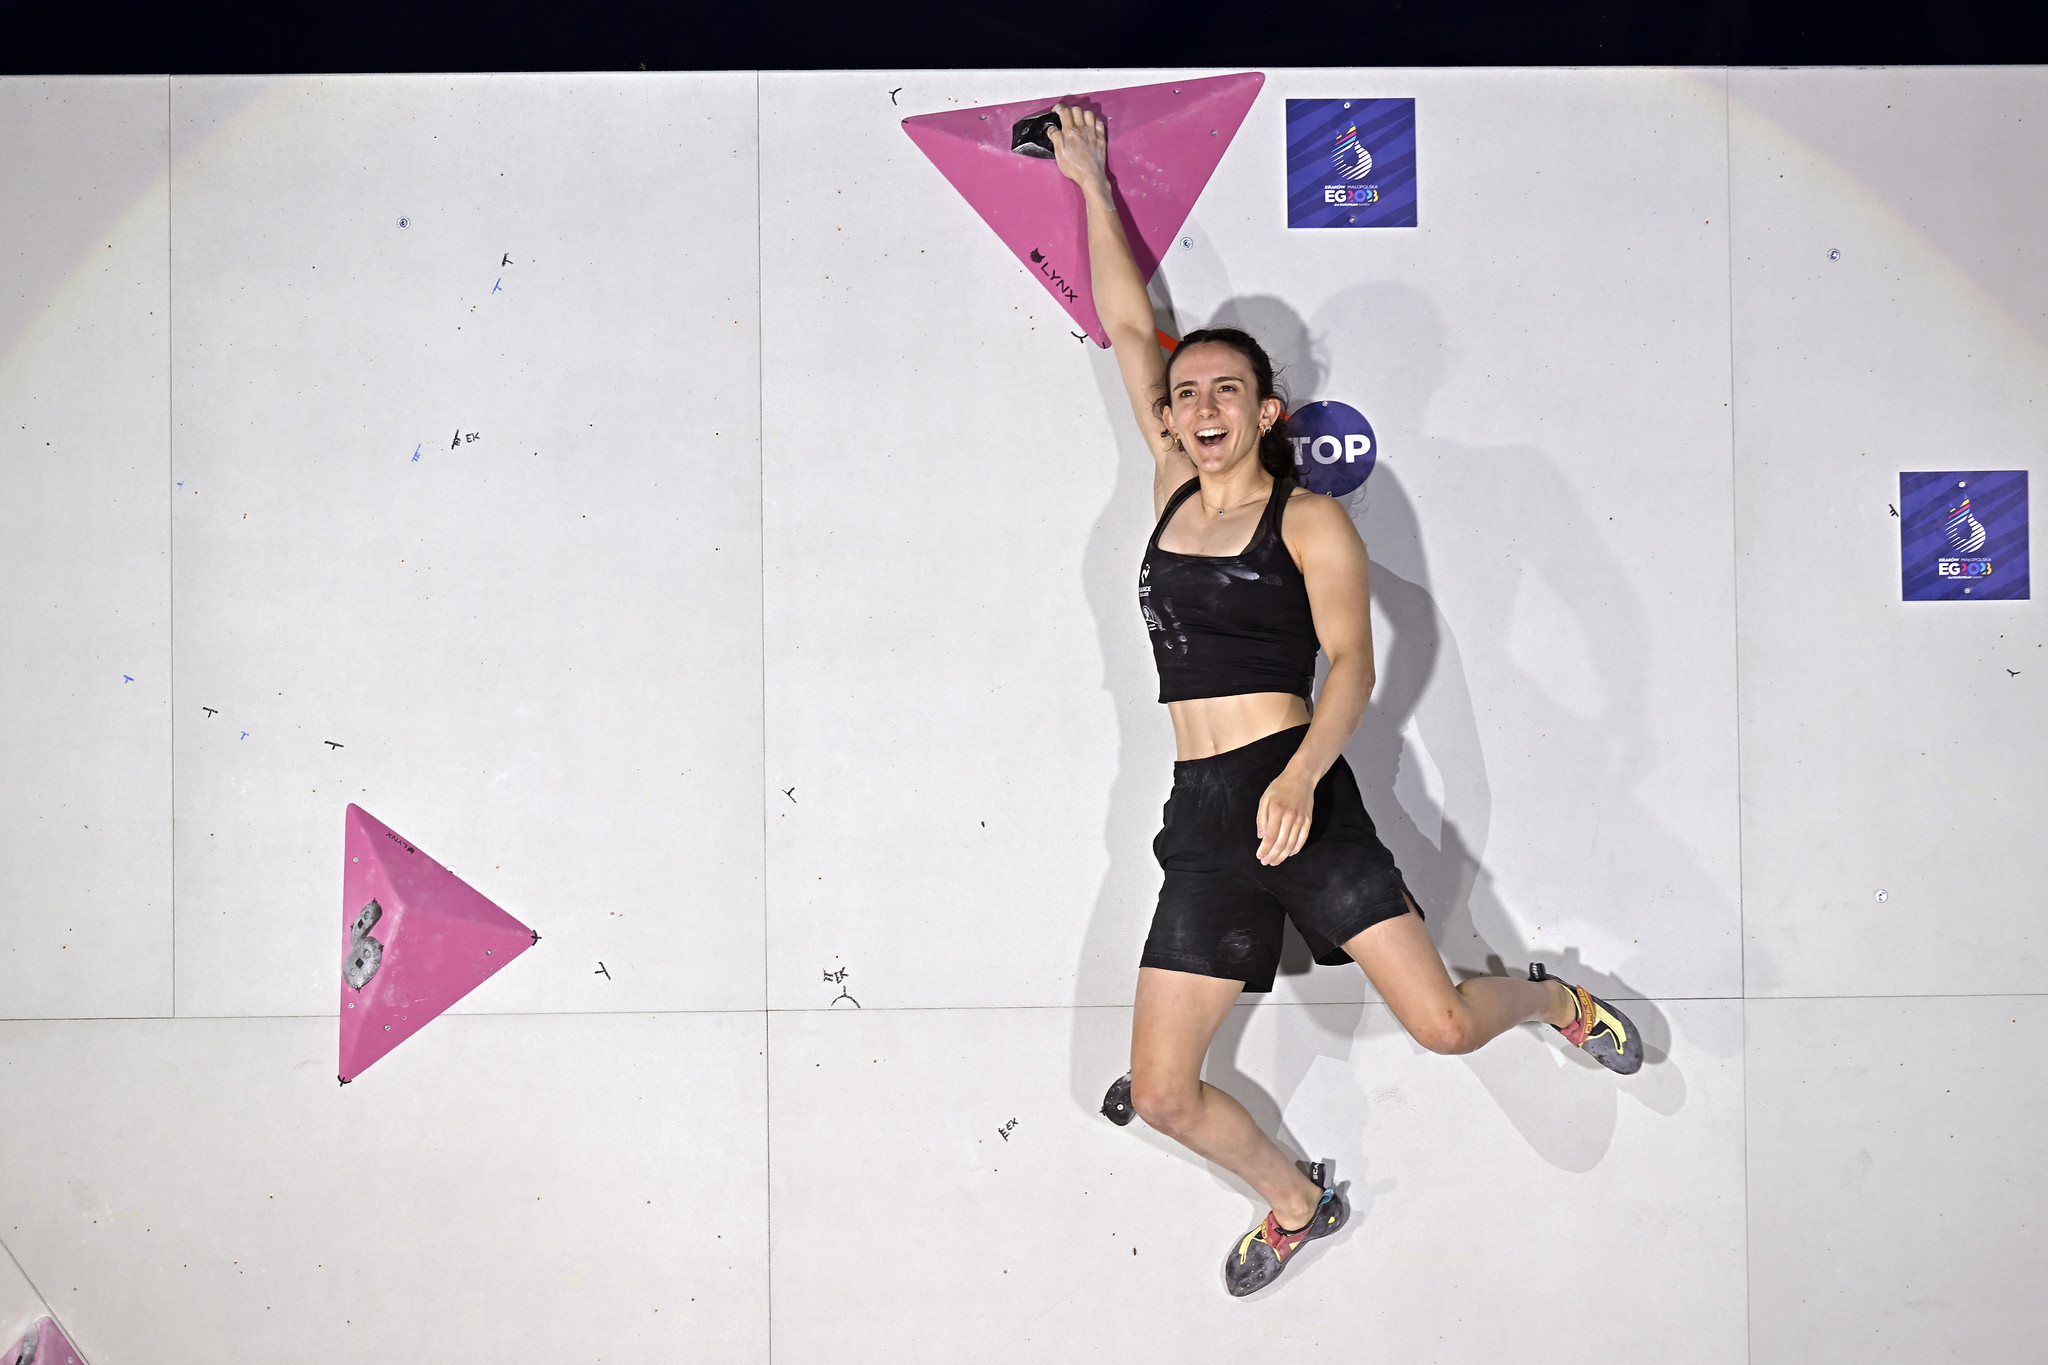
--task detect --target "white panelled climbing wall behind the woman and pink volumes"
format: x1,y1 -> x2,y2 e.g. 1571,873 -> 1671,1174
0,70 -> 2048,1365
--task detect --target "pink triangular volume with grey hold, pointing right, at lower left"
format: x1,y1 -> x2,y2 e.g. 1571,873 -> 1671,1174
340,806 -> 539,1085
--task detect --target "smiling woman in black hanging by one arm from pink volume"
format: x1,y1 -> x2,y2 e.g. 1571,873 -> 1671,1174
1049,104 -> 1642,1295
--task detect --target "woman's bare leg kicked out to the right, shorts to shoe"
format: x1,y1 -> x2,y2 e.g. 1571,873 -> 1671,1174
1343,900 -> 1579,1054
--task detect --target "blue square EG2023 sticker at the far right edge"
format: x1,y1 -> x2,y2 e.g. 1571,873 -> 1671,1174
1898,469 -> 2032,602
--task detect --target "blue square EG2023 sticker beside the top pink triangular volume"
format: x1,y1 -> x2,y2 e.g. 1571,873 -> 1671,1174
1286,100 -> 1415,227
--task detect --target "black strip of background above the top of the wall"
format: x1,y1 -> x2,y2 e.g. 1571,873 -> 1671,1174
12,0 -> 2048,74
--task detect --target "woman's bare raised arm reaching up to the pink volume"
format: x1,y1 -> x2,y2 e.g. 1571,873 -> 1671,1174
1049,104 -> 1194,505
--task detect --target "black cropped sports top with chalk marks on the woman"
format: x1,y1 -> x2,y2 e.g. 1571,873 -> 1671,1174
1139,479 -> 1319,702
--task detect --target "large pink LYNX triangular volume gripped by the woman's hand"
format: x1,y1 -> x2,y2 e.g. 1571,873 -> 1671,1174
903,72 -> 1266,346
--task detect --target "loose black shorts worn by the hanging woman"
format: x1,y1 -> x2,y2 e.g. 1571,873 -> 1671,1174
1139,724 -> 1419,990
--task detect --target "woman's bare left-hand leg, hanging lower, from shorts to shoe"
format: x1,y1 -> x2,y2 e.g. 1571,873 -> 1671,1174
1130,965 -> 1327,1228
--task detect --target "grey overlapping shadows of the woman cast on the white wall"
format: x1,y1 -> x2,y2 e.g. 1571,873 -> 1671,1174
1073,282 -> 1718,1193
